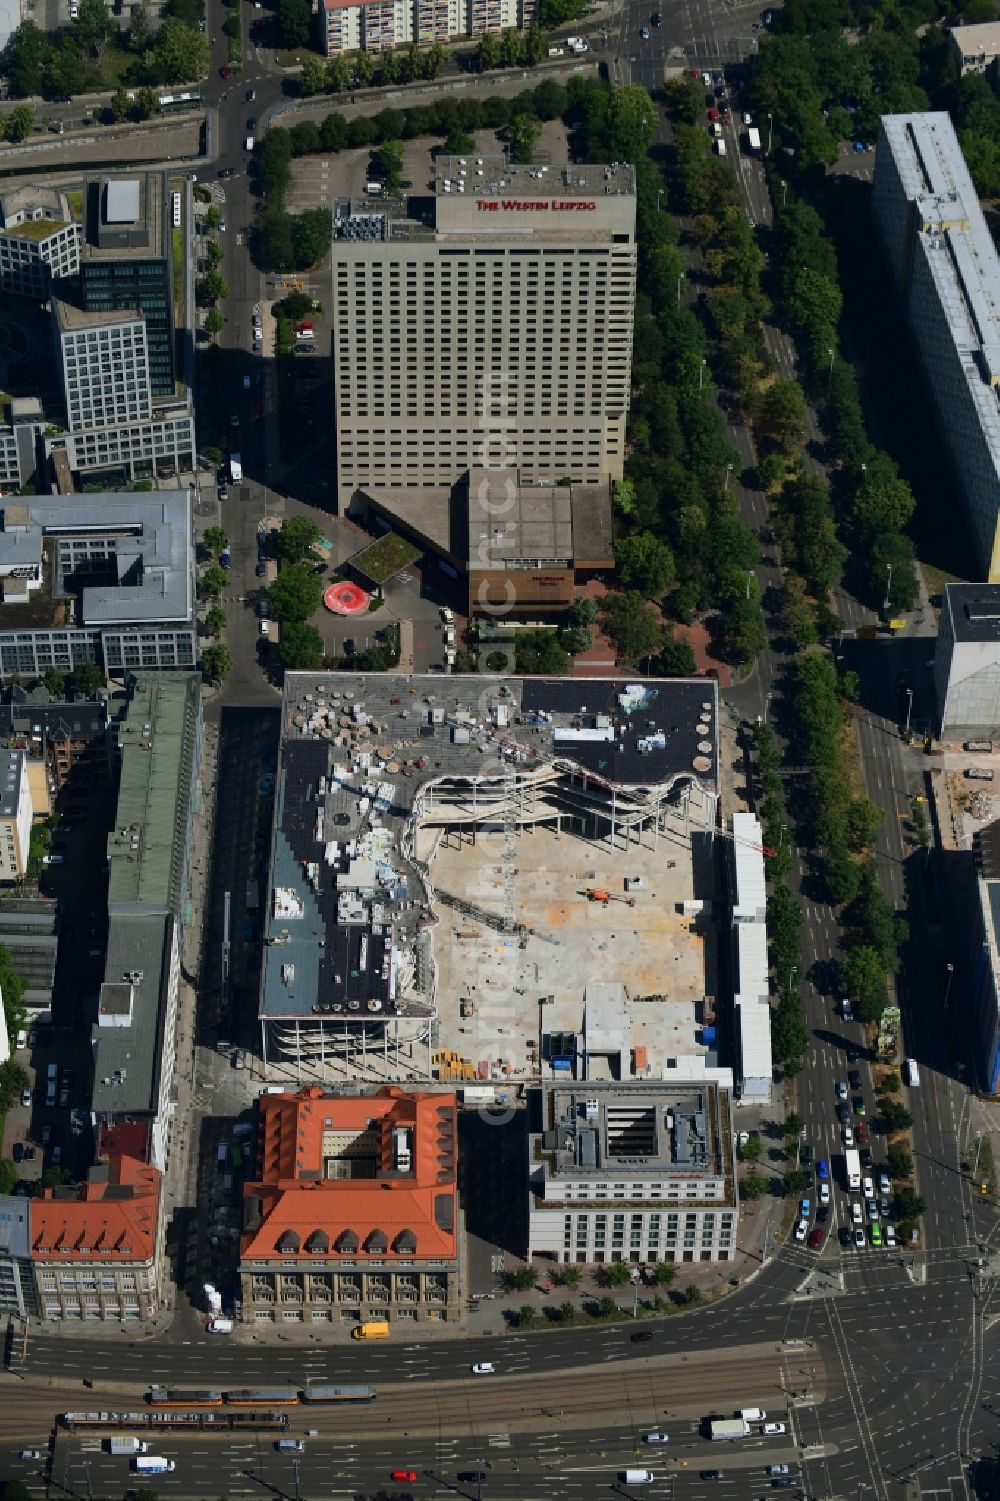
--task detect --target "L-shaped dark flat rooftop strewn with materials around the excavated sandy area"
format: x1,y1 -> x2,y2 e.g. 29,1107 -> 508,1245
261,672 -> 718,1021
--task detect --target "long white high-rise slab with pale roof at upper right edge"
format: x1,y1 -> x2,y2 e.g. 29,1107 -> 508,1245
874,113 -> 1000,579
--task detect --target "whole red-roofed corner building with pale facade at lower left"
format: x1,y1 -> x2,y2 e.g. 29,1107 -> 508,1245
30,1156 -> 165,1324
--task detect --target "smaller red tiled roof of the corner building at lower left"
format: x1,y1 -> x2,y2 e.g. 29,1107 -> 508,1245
30,1156 -> 162,1261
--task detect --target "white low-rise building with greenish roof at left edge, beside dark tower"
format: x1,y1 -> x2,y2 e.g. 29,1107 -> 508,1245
0,185 -> 83,302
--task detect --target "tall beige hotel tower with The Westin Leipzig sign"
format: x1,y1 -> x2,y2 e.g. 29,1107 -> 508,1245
332,156 -> 635,509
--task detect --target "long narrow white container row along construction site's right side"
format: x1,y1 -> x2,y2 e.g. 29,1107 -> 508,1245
730,814 -> 773,1105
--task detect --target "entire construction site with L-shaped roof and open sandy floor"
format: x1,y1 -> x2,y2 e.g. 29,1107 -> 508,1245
260,672 -> 719,1100
